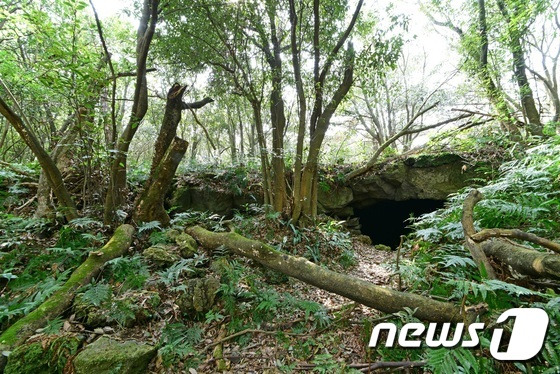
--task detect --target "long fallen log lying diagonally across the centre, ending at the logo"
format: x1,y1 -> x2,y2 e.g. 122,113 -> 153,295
187,226 -> 470,322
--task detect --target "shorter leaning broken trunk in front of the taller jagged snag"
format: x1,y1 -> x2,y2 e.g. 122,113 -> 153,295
133,137 -> 189,226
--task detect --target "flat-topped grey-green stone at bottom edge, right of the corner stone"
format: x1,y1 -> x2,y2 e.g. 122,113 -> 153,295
74,336 -> 157,374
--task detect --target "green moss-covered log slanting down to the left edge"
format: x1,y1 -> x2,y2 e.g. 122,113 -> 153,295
0,225 -> 134,364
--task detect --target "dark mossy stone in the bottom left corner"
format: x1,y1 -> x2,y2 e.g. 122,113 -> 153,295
4,335 -> 84,374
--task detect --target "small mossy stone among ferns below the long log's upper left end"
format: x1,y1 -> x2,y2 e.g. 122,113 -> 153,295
176,277 -> 220,314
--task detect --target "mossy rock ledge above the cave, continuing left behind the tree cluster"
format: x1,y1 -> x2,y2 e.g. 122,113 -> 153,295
170,153 -> 477,218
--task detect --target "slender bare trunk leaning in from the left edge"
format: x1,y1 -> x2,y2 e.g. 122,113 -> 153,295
0,98 -> 78,221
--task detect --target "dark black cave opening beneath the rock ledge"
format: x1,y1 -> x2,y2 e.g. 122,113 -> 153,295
354,199 -> 444,249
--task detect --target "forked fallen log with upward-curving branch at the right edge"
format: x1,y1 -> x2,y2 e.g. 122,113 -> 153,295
462,190 -> 560,279
